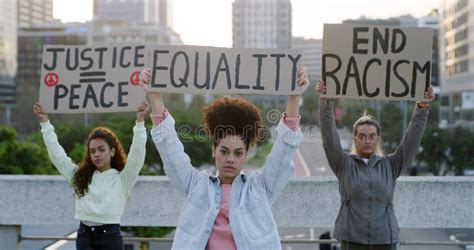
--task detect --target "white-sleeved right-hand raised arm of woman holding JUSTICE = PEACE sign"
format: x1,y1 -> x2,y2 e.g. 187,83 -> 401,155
120,101 -> 148,196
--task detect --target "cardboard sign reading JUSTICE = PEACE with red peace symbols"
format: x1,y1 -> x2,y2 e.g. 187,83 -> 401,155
39,45 -> 146,113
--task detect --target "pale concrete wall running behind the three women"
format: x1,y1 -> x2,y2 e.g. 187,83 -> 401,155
0,175 -> 474,228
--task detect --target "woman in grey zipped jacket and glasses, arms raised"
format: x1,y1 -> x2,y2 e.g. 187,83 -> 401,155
316,81 -> 434,250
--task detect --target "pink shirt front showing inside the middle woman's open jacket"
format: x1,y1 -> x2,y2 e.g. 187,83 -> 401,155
206,184 -> 237,250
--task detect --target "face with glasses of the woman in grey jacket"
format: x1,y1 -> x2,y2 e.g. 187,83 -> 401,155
354,124 -> 379,158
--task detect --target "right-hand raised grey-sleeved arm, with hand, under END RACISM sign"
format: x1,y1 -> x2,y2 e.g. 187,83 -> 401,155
387,87 -> 434,177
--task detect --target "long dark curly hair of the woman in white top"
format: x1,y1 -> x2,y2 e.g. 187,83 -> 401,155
72,127 -> 127,197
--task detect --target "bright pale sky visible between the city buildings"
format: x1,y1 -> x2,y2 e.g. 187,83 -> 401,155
53,0 -> 439,47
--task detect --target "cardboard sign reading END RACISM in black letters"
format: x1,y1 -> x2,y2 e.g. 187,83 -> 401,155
322,24 -> 433,100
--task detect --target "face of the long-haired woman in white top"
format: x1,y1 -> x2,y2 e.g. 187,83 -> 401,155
89,139 -> 115,172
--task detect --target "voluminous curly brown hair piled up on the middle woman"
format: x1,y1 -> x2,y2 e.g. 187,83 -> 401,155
203,96 -> 263,150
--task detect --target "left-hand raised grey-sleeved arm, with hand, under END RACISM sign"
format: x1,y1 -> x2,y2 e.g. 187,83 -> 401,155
316,81 -> 347,177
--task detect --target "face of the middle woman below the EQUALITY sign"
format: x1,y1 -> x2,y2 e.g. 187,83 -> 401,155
212,135 -> 247,184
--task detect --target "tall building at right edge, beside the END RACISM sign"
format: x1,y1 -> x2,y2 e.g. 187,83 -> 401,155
439,0 -> 474,127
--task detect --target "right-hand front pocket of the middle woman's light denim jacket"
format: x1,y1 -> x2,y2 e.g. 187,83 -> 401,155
242,197 -> 274,240
